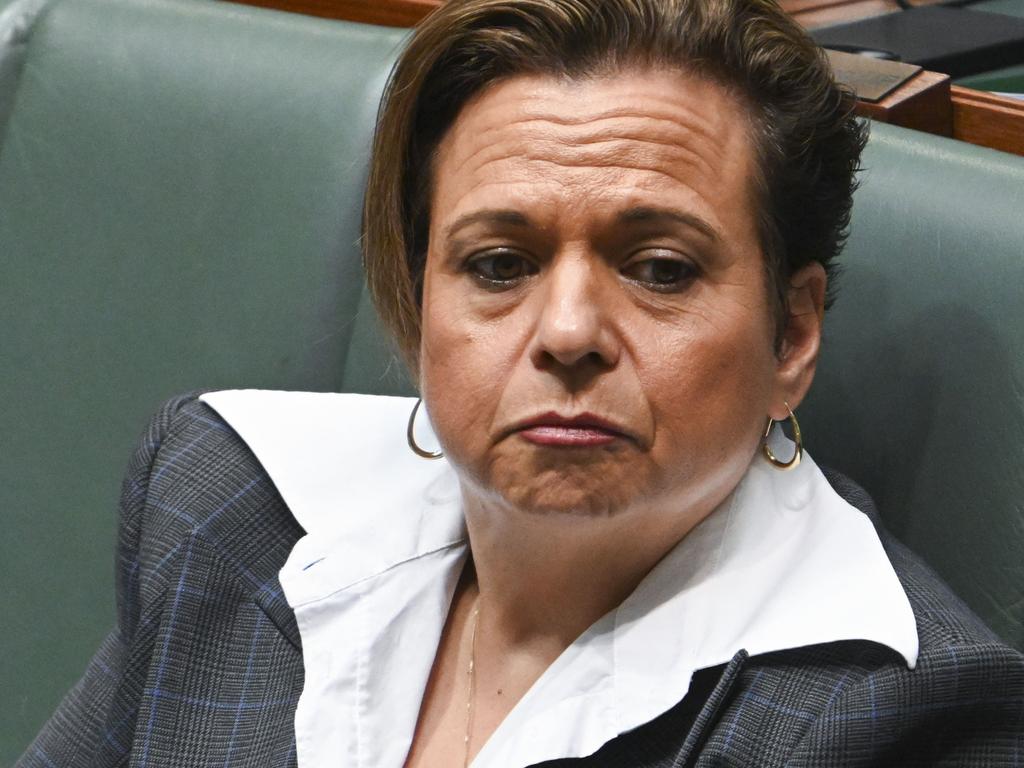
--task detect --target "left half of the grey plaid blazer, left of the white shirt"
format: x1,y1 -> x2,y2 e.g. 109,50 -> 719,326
25,393 -> 303,766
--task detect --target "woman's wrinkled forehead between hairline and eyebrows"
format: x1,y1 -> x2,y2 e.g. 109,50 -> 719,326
431,70 -> 754,241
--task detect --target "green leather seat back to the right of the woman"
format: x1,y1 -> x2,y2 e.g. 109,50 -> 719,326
801,125 -> 1024,648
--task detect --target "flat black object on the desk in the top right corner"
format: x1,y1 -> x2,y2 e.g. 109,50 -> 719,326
811,6 -> 1024,77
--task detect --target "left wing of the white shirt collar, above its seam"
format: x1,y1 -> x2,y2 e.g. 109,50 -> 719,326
201,389 -> 466,608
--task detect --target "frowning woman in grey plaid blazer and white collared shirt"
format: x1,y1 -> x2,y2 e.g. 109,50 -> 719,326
23,0 -> 1024,768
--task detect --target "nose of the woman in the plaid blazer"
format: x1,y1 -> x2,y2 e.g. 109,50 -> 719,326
531,255 -> 620,374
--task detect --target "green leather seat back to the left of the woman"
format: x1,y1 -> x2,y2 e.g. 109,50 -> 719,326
0,0 -> 408,765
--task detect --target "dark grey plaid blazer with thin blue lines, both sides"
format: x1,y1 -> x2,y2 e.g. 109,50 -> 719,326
17,396 -> 1024,768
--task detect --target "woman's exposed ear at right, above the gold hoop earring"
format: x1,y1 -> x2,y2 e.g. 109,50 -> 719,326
769,261 -> 827,421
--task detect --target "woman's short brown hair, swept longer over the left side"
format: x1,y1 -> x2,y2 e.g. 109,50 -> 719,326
362,0 -> 865,372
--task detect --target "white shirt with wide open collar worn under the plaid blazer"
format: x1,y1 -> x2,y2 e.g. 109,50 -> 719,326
202,390 -> 918,768
